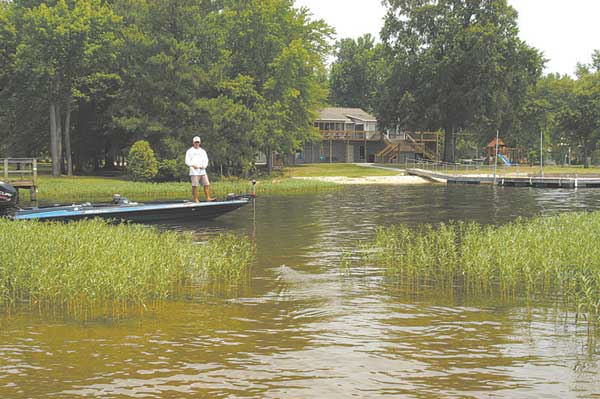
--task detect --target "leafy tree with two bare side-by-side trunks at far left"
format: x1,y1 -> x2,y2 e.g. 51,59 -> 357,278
14,0 -> 119,176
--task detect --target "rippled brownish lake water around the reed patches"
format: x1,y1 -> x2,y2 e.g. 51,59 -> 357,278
0,185 -> 600,398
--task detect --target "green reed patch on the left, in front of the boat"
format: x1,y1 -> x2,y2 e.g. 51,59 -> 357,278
0,219 -> 254,319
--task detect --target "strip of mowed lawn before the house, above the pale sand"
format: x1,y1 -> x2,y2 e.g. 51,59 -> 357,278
283,163 -> 401,177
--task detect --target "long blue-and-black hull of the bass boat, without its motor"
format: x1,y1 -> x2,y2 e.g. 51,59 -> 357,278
13,197 -> 251,222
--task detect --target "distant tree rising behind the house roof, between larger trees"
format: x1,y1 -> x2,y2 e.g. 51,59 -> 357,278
329,34 -> 380,111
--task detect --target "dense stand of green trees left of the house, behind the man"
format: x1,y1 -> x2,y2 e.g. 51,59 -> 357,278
0,0 -> 332,174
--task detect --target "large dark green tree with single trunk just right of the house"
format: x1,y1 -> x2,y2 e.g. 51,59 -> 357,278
376,0 -> 543,161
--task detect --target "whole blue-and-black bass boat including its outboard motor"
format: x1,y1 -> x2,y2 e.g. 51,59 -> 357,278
0,181 -> 256,222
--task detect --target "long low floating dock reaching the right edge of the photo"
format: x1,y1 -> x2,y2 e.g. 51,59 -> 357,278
406,169 -> 600,188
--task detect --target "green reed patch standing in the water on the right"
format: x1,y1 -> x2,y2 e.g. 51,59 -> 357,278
364,212 -> 600,320
